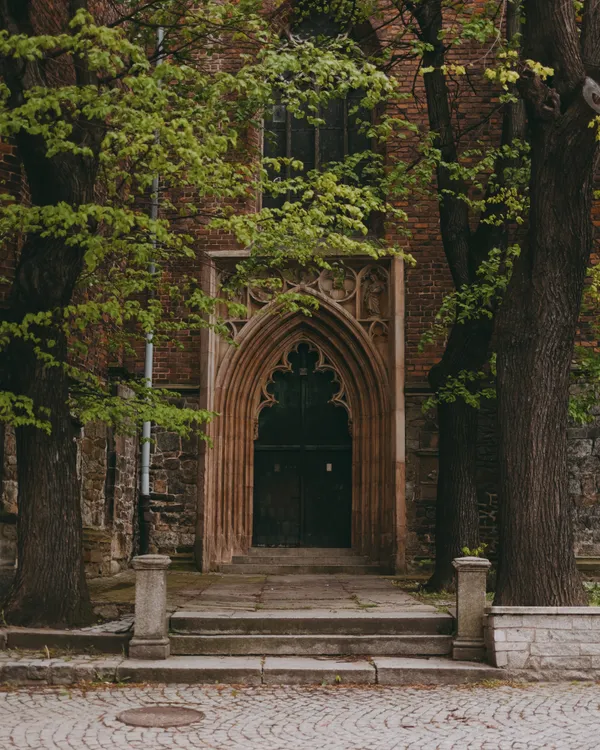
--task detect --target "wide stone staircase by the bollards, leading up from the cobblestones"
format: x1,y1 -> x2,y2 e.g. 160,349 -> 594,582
169,610 -> 503,685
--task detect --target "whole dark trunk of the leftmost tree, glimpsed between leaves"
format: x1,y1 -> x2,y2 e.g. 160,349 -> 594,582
0,0 -> 102,626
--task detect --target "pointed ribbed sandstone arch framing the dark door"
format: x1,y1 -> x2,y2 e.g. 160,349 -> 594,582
203,293 -> 395,569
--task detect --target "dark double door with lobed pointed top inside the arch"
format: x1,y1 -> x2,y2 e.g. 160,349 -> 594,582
253,344 -> 352,547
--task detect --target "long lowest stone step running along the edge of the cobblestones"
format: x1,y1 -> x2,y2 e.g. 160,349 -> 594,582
0,656 -> 502,688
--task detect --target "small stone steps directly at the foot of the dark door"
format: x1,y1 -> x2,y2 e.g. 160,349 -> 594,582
219,547 -> 384,575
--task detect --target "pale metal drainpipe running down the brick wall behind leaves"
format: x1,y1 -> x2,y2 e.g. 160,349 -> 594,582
139,28 -> 165,555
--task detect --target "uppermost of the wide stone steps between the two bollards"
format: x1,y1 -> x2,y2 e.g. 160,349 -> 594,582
170,610 -> 454,637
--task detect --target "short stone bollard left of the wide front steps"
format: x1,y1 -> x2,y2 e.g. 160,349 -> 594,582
129,555 -> 171,659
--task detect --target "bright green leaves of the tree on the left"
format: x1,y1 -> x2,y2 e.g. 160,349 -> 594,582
0,0 -> 405,435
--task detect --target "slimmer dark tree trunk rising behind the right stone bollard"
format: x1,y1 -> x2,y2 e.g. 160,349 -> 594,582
411,0 -> 523,591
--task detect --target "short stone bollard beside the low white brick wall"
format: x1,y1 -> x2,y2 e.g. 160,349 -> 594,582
452,557 -> 492,661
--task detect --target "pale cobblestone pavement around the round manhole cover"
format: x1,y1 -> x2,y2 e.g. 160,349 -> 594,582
0,683 -> 600,750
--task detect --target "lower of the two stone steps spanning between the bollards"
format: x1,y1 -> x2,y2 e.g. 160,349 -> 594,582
170,635 -> 452,656
